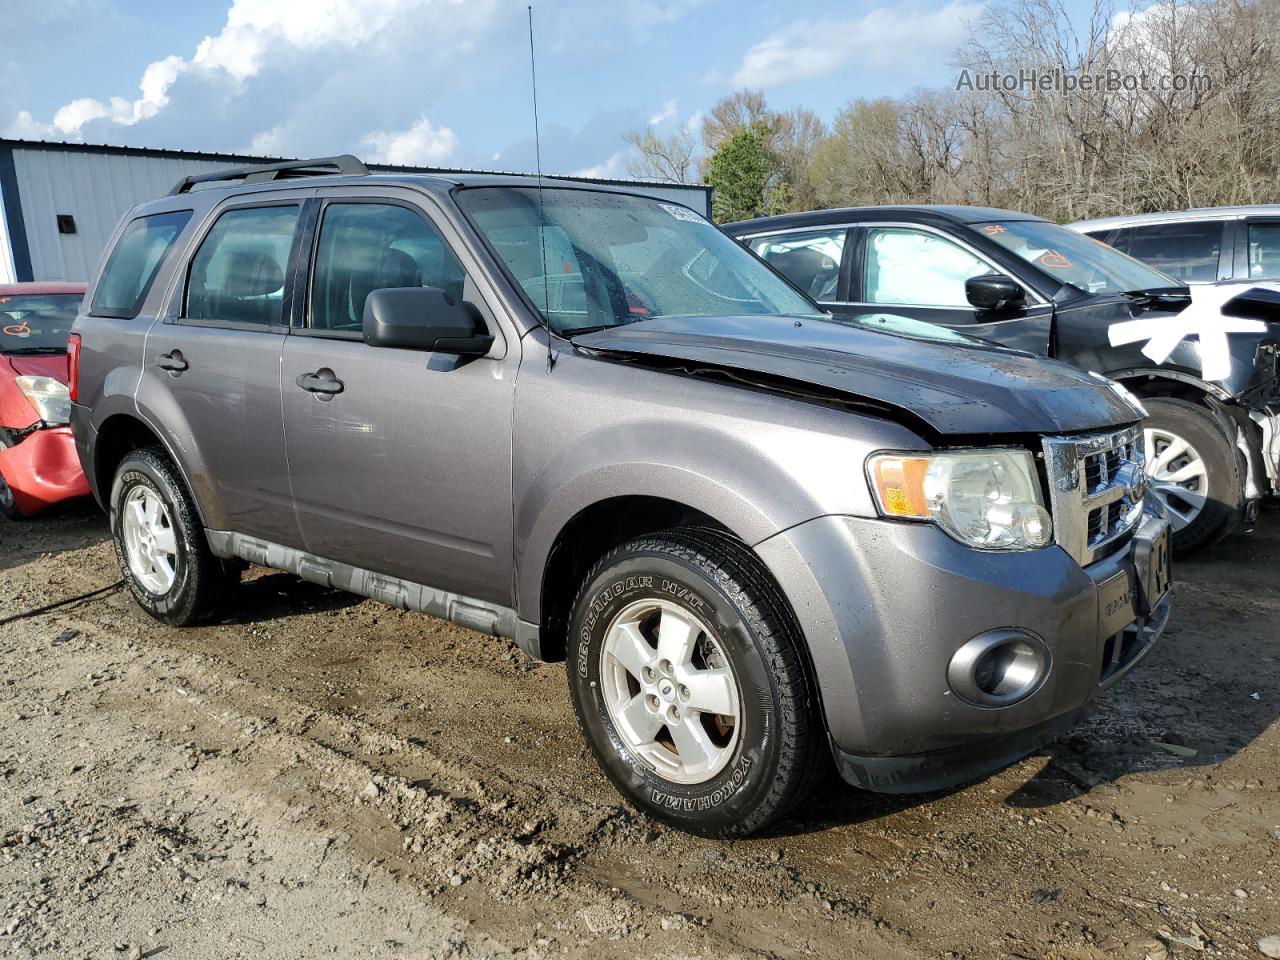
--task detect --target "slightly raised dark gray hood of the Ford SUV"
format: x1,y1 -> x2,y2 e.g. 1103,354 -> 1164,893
573,316 -> 1139,436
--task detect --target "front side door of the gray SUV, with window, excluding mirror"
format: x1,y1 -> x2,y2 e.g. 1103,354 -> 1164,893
280,193 -> 516,604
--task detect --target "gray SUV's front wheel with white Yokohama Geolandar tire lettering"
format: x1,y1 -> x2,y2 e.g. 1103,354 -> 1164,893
567,529 -> 826,837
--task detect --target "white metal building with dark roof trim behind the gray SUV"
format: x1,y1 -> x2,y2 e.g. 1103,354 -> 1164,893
0,140 -> 712,283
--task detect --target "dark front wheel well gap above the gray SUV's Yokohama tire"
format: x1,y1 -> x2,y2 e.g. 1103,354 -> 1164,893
539,497 -> 728,662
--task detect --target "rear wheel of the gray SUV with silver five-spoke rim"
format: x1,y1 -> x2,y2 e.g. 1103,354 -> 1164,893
110,447 -> 238,626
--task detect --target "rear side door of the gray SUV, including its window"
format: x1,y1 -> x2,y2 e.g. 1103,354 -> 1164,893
138,191 -> 306,547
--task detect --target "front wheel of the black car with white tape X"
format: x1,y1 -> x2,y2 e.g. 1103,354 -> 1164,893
1143,397 -> 1244,554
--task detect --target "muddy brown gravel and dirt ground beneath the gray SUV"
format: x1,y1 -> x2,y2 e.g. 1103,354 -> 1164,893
0,504 -> 1280,960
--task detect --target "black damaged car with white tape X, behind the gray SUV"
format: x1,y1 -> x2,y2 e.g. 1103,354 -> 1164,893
724,206 -> 1280,553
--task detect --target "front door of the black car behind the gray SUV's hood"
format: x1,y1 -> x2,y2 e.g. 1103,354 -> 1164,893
829,224 -> 1053,356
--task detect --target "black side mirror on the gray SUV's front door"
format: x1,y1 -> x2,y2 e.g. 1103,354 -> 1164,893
364,287 -> 493,357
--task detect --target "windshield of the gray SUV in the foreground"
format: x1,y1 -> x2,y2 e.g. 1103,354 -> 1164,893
457,187 -> 822,334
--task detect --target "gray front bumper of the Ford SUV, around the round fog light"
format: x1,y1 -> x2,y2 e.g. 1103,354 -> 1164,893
756,507 -> 1170,792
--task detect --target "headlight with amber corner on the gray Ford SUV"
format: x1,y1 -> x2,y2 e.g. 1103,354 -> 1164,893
868,449 -> 1053,550
